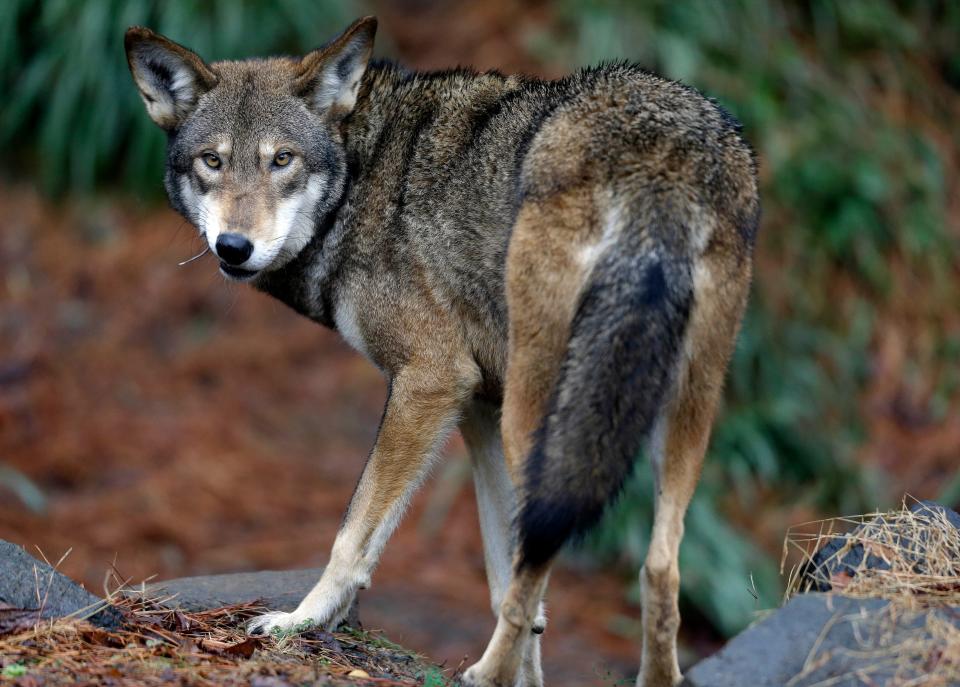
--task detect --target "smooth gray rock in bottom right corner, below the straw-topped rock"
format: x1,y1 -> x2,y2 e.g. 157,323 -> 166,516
682,594 -> 960,687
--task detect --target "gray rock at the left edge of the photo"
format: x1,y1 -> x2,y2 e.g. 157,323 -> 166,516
0,540 -> 123,629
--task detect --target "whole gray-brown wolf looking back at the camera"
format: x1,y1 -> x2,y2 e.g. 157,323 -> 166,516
126,18 -> 759,687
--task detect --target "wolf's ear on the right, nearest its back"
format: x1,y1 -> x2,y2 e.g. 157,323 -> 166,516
293,17 -> 377,119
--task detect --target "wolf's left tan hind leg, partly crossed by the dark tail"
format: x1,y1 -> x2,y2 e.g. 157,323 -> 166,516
464,190 -> 594,687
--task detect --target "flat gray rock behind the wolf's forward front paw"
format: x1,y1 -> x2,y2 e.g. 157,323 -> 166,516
135,568 -> 360,627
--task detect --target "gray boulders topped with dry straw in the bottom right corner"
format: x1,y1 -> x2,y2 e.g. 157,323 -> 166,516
683,501 -> 960,687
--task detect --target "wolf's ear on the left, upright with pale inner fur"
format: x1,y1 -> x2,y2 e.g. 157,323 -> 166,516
123,26 -> 217,130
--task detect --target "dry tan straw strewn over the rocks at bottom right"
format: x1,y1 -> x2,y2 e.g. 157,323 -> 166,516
781,501 -> 960,687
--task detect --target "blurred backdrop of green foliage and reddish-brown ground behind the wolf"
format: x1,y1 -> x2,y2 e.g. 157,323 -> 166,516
0,0 -> 960,685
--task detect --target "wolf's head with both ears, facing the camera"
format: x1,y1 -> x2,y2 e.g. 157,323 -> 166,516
125,17 -> 377,281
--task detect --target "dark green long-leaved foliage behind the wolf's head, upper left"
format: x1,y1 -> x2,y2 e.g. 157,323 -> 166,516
0,0 -> 354,195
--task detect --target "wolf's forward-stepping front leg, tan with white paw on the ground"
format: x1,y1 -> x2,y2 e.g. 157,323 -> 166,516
249,360 -> 477,634
